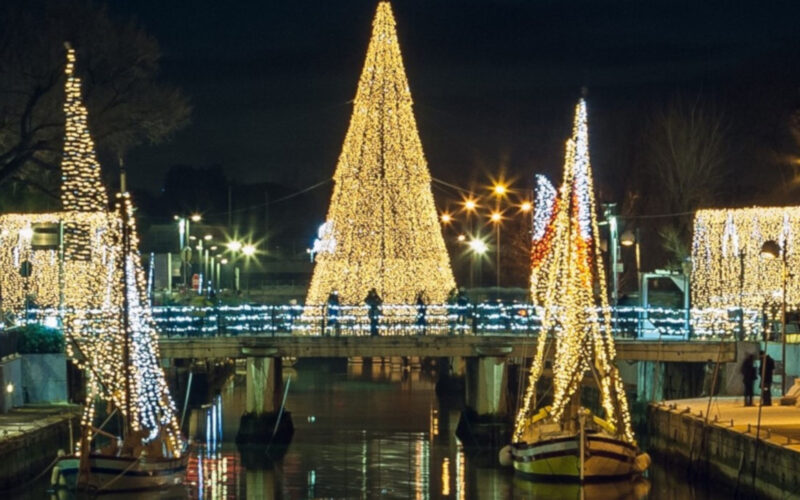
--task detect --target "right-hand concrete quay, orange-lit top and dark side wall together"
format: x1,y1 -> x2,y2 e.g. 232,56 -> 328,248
647,396 -> 800,498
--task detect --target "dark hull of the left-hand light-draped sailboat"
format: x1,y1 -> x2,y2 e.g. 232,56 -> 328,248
51,455 -> 188,493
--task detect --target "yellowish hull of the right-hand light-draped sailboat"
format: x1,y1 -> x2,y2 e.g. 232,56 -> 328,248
511,435 -> 640,481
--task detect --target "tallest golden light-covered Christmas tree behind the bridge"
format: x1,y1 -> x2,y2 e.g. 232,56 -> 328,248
306,2 -> 455,305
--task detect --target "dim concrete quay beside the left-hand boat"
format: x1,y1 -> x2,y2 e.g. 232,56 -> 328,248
0,404 -> 80,490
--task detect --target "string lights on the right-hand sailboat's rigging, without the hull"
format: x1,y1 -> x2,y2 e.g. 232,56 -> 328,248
514,99 -> 634,443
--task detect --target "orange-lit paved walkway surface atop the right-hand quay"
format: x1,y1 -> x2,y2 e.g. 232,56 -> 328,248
658,396 -> 800,452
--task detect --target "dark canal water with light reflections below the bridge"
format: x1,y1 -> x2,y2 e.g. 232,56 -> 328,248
10,360 -> 732,500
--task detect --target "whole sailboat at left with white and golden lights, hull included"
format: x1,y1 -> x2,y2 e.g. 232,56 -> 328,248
51,188 -> 189,494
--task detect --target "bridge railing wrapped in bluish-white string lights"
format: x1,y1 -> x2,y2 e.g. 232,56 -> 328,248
4,302 -> 763,340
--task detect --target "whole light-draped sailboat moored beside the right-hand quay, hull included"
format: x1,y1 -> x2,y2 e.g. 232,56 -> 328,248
501,99 -> 650,482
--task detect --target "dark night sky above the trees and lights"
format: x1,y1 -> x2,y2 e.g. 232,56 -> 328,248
109,0 -> 800,203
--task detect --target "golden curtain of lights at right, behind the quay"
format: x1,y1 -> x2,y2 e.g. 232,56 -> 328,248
691,207 -> 800,324
